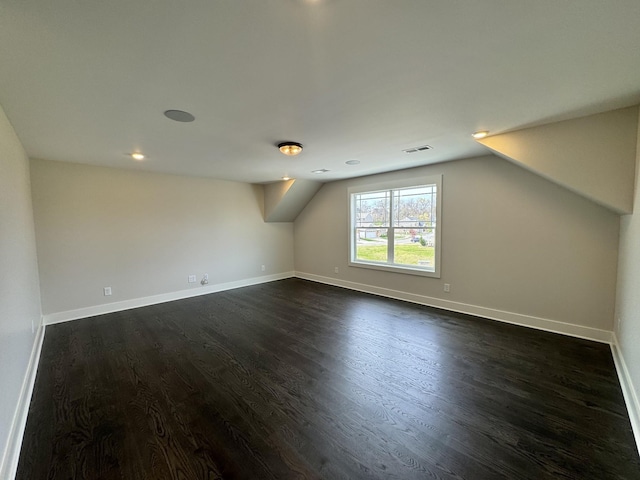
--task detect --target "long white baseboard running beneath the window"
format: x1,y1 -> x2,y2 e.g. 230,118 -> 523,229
296,272 -> 611,343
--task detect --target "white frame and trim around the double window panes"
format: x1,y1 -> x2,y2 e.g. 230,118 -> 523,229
348,175 -> 442,278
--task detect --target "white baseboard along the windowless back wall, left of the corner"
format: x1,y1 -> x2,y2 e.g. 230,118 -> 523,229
44,272 -> 295,325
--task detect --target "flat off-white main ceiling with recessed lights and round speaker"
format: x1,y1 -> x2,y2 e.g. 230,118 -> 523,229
0,0 -> 640,183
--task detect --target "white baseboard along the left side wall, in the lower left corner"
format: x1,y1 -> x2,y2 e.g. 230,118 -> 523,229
0,323 -> 45,479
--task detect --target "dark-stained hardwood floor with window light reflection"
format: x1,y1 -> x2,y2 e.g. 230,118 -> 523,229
17,279 -> 640,480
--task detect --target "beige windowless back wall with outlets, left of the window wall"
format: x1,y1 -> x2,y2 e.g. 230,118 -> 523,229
31,160 -> 293,314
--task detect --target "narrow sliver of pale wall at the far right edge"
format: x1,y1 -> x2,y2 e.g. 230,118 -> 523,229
616,109 -> 640,442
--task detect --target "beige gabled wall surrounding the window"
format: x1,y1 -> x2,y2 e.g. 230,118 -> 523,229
295,156 -> 619,331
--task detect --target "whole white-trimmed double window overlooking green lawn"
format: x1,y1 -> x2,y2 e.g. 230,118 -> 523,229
349,176 -> 442,277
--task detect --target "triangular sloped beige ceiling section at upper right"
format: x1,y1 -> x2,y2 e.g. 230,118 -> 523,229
478,106 -> 639,214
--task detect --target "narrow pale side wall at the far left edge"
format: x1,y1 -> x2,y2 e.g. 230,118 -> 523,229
0,108 -> 41,478
